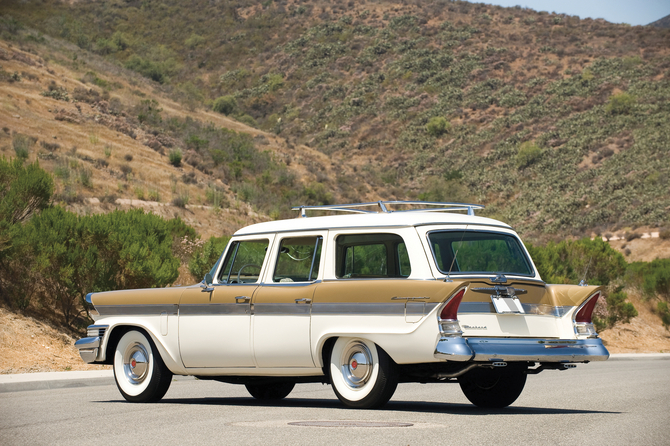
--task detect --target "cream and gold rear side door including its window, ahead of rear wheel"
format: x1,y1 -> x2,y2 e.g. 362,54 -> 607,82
252,233 -> 323,367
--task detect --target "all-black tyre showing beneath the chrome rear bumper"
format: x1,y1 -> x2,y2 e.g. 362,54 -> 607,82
458,367 -> 526,409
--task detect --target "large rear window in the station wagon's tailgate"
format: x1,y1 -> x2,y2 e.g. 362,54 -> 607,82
428,231 -> 533,276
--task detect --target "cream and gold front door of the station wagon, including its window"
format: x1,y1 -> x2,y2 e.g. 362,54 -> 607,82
179,236 -> 274,368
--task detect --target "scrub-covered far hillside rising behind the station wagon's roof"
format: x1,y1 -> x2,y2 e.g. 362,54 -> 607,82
0,0 -> 670,237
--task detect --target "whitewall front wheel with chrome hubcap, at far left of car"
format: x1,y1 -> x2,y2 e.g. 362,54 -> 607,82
114,330 -> 172,403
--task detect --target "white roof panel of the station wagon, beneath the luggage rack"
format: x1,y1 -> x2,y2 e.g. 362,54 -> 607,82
234,211 -> 512,236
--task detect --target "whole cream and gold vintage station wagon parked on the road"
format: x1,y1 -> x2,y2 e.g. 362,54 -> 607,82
76,201 -> 609,408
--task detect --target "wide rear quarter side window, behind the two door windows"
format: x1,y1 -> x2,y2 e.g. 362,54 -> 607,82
335,234 -> 412,279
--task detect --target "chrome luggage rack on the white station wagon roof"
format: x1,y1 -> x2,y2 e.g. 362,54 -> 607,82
291,200 -> 484,218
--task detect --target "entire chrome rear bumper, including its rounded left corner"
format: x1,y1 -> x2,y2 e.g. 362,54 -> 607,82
434,337 -> 610,362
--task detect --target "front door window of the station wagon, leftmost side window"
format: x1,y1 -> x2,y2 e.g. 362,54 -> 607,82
219,239 -> 268,283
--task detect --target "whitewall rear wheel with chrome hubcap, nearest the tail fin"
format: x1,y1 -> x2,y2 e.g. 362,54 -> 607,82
330,338 -> 398,409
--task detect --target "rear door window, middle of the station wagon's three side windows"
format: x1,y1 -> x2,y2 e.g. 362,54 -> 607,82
272,236 -> 323,283
